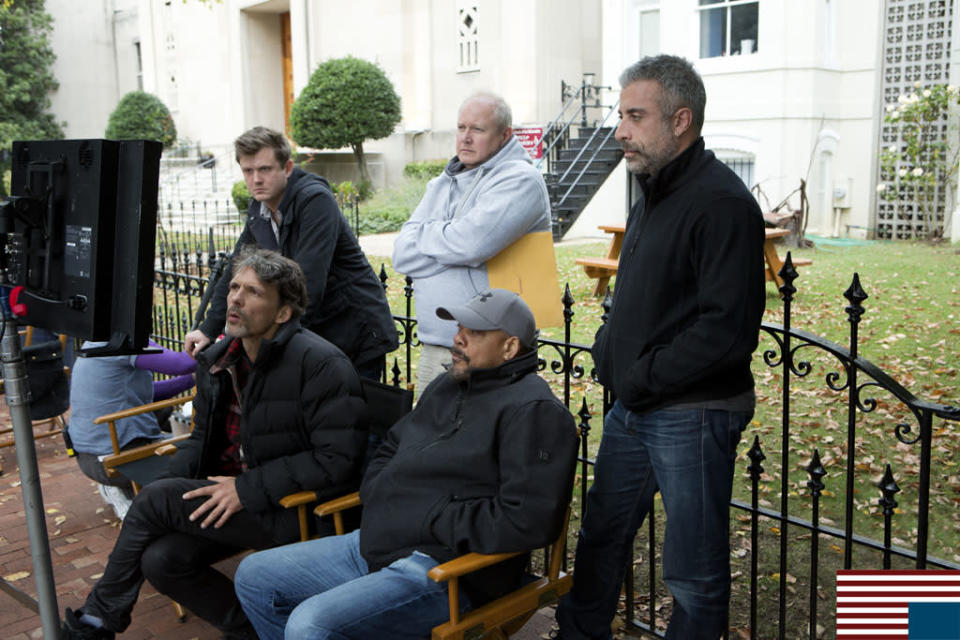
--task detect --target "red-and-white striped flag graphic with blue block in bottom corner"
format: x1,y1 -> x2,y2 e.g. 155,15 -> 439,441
837,570 -> 960,640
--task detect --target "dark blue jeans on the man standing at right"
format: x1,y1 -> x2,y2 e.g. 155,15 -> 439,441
557,402 -> 752,640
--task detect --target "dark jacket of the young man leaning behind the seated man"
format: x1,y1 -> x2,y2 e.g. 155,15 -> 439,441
200,168 -> 397,364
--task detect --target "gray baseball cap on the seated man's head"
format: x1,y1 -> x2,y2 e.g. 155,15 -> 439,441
437,289 -> 540,349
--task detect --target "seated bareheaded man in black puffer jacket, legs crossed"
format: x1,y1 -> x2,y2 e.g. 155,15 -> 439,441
63,249 -> 367,639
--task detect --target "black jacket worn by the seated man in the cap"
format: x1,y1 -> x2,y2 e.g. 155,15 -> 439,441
360,353 -> 578,606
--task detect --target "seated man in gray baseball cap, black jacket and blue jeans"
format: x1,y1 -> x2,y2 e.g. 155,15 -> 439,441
234,289 -> 577,638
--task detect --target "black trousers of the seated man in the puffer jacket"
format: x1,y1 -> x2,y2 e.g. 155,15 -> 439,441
83,478 -> 299,638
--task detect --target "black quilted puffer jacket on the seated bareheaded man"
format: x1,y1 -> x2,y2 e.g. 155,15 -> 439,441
167,320 -> 367,518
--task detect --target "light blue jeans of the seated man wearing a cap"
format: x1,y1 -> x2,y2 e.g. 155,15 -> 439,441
234,531 -> 462,640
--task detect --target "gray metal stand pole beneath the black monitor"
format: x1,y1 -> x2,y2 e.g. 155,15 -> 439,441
0,311 -> 60,640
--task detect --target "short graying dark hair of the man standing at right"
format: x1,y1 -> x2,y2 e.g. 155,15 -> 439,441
620,55 -> 707,133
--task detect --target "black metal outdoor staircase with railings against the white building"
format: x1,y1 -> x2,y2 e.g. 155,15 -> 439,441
539,74 -> 623,240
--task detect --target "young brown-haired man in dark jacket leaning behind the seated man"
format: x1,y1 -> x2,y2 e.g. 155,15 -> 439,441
184,127 -> 397,379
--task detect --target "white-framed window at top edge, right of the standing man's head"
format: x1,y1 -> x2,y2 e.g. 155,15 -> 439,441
697,0 -> 760,58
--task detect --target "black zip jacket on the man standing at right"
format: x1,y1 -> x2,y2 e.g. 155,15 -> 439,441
593,138 -> 766,412
